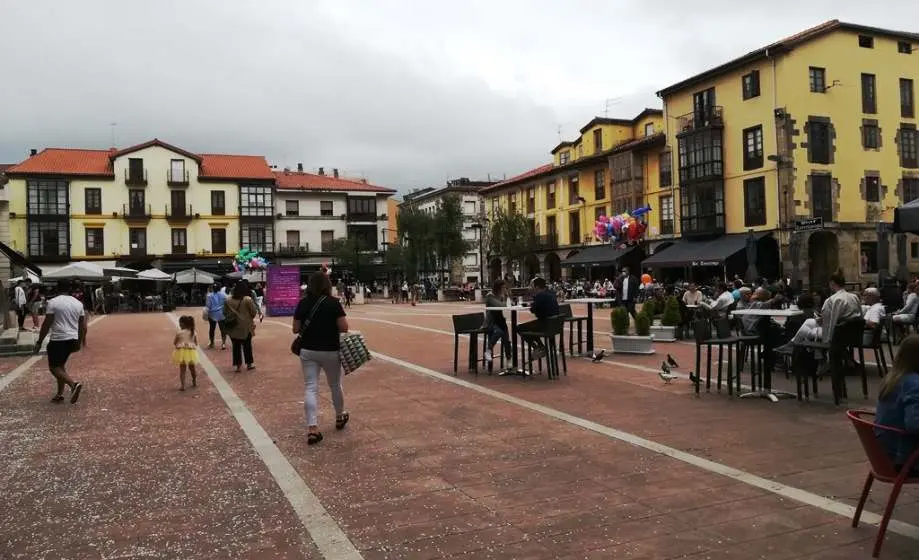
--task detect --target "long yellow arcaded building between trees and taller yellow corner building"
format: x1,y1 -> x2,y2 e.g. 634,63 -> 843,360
482,109 -> 665,280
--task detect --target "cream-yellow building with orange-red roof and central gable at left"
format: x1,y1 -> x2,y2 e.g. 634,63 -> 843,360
6,140 -> 274,271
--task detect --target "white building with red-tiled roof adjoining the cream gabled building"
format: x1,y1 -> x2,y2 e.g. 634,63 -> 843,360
274,165 -> 396,269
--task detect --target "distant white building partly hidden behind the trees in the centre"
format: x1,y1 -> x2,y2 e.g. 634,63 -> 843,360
400,177 -> 495,283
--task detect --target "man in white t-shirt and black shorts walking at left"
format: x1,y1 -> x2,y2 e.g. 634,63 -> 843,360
35,280 -> 86,404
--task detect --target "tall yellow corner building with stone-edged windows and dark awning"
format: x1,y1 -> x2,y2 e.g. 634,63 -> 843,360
646,21 -> 919,286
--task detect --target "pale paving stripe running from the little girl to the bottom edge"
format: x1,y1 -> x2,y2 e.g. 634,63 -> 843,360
168,313 -> 364,560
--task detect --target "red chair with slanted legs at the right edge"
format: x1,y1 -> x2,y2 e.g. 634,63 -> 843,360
846,410 -> 919,558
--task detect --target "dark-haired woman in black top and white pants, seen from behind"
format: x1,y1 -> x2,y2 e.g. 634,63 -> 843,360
293,272 -> 350,445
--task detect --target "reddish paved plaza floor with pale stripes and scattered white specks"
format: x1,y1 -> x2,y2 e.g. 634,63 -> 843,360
0,302 -> 919,560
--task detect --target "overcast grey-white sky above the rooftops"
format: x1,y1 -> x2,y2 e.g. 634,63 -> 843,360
0,0 -> 919,190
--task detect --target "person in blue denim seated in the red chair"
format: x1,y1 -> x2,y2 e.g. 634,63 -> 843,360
874,336 -> 919,476
